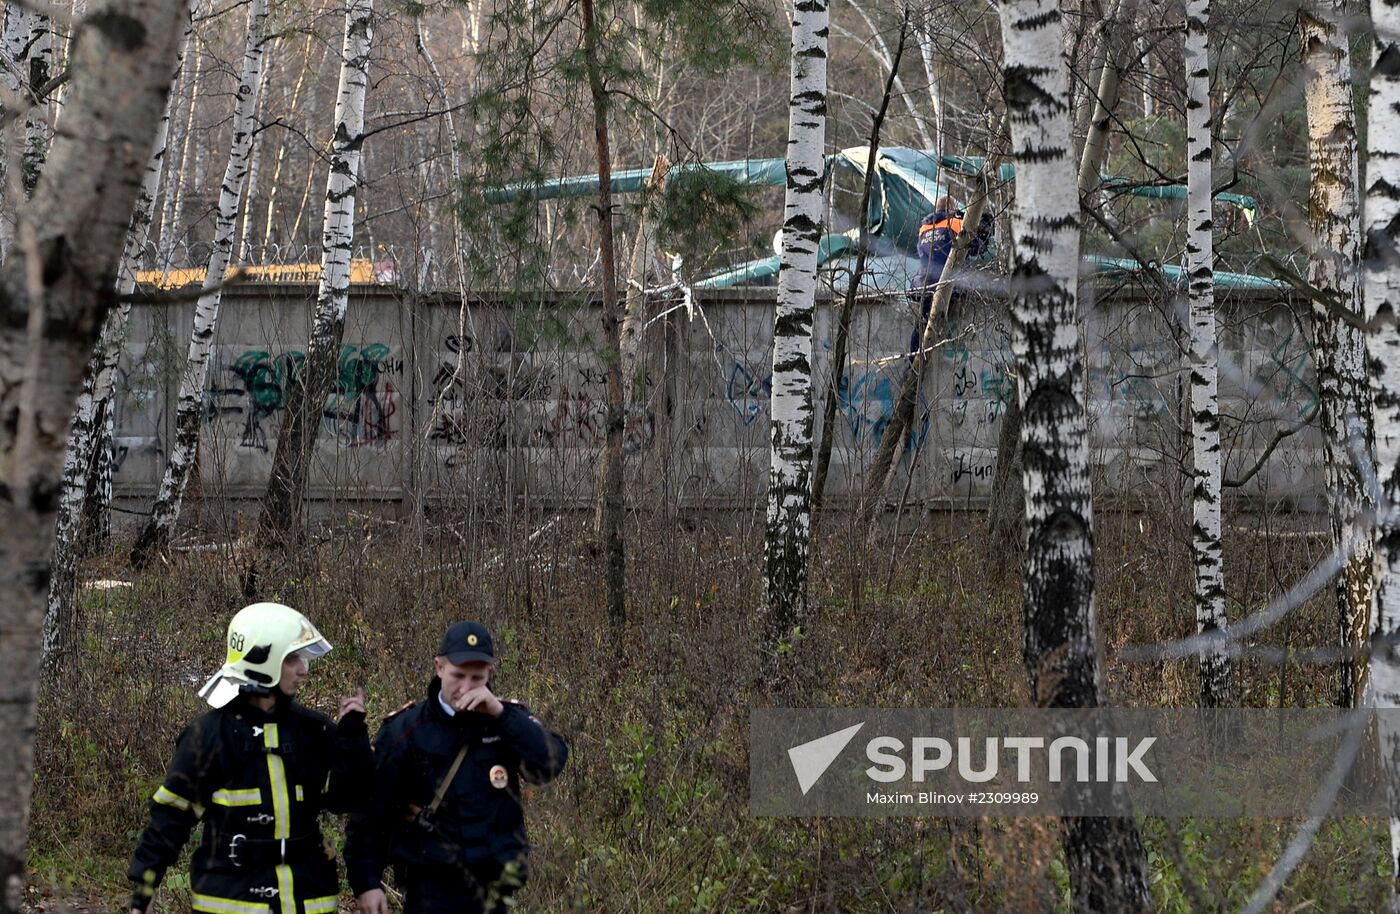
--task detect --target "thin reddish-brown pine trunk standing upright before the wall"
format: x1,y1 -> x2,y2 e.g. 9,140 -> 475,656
580,0 -> 627,634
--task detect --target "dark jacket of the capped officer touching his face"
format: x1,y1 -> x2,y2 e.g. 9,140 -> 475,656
346,676 -> 568,896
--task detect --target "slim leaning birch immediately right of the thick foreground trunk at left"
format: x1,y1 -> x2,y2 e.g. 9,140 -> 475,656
43,10 -> 193,676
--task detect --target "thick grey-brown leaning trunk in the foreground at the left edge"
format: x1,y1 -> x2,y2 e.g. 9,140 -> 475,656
0,0 -> 183,895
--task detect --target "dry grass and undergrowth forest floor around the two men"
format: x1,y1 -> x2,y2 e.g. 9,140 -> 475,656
28,503 -> 1389,914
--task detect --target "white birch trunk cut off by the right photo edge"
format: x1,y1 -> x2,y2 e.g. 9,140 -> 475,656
1362,0 -> 1400,895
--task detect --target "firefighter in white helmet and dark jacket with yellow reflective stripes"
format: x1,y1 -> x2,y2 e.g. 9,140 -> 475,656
129,603 -> 374,914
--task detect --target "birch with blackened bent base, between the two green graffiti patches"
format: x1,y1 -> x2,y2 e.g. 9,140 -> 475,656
258,0 -> 374,546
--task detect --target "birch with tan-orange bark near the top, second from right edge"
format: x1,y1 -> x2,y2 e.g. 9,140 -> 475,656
1298,0 -> 1375,707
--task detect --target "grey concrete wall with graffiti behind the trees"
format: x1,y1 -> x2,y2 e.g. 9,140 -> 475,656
116,286 -> 1320,507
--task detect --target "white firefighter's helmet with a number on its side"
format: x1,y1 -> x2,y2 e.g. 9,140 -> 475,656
199,603 -> 330,708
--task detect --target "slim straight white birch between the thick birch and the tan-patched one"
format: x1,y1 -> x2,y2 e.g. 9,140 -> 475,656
1184,0 -> 1231,708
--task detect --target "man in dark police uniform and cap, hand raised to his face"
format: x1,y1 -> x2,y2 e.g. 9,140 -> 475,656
346,621 -> 568,914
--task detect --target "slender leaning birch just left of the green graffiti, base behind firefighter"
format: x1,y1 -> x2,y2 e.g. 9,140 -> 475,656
132,0 -> 267,568
